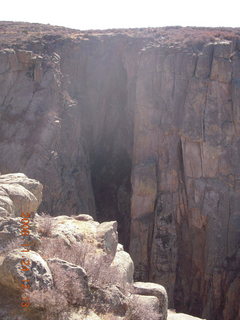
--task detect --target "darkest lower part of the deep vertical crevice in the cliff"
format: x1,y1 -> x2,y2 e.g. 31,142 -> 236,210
91,136 -> 131,250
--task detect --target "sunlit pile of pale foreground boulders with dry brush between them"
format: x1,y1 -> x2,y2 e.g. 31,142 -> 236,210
0,174 -> 167,320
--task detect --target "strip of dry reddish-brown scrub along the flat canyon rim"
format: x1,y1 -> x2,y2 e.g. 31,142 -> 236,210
0,21 -> 240,48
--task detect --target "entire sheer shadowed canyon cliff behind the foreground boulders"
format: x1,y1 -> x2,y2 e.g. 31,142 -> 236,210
0,24 -> 240,320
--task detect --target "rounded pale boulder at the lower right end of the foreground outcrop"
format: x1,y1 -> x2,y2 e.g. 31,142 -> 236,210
133,282 -> 168,320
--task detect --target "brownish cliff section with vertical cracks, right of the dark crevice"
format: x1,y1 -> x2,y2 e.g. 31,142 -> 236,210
130,41 -> 240,319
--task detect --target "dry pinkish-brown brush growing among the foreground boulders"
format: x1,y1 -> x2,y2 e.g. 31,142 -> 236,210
0,214 -> 165,320
